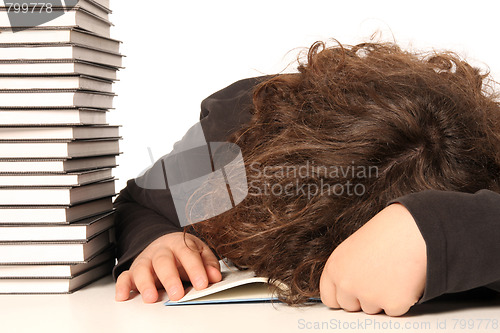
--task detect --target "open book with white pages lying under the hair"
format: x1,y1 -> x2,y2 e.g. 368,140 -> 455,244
165,262 -> 319,306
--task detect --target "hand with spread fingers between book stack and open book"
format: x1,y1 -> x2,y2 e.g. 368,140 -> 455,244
115,232 -> 222,303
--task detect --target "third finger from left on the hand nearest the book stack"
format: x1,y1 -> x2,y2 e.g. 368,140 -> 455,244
153,251 -> 184,301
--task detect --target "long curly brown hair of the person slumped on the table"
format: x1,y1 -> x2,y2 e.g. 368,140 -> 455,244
193,42 -> 500,304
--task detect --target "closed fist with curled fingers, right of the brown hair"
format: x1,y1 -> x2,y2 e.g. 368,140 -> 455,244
319,204 -> 427,316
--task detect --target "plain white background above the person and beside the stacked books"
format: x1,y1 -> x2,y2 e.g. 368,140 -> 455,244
108,0 -> 500,190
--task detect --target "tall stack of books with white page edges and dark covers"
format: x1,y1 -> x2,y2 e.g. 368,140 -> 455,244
0,0 -> 122,293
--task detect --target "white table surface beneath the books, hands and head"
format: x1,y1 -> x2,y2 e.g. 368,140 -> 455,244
0,276 -> 500,333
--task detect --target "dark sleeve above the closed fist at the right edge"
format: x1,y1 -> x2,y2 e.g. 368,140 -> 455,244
391,190 -> 500,303
